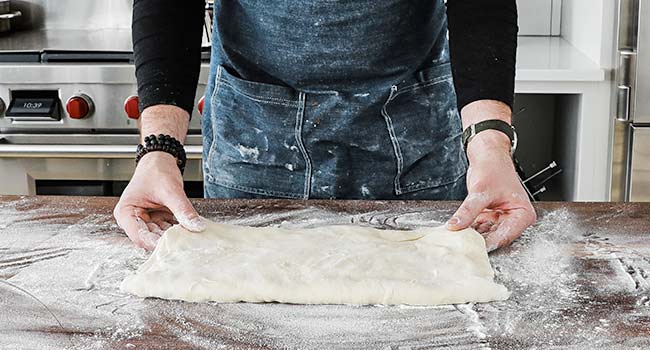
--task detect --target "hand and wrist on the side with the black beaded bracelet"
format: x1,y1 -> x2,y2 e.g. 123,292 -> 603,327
113,106 -> 206,250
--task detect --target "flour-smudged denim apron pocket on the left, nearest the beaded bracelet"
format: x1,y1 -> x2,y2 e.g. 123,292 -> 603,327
205,66 -> 310,198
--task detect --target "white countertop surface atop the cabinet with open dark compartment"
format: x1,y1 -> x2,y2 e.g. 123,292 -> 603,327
516,37 -> 606,82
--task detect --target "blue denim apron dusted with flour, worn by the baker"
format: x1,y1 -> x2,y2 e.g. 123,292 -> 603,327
202,0 -> 467,200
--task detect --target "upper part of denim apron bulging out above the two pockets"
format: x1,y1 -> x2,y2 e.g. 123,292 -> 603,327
212,0 -> 449,92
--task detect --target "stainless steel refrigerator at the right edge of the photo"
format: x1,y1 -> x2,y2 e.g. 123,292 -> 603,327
612,0 -> 650,202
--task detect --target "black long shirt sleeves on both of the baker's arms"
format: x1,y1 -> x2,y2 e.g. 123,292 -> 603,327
133,0 -> 518,114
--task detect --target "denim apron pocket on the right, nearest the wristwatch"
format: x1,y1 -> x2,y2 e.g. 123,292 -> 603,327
382,63 -> 467,195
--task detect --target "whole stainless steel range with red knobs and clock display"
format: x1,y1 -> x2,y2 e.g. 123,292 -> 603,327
0,0 -> 211,196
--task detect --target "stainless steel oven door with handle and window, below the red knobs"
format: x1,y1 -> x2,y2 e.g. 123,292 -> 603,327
0,134 -> 202,197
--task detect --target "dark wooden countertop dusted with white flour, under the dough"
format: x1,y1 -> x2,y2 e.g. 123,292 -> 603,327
0,196 -> 650,349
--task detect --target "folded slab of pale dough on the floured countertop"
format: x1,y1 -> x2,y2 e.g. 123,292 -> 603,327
121,222 -> 510,305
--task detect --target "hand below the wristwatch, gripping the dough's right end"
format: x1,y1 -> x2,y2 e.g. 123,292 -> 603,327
447,130 -> 537,251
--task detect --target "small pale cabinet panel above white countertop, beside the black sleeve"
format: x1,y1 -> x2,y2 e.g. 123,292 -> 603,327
517,0 -> 562,36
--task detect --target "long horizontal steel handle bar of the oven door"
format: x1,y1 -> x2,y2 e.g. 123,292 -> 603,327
0,144 -> 203,159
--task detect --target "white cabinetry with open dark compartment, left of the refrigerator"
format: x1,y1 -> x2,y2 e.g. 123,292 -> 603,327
506,0 -> 616,201
